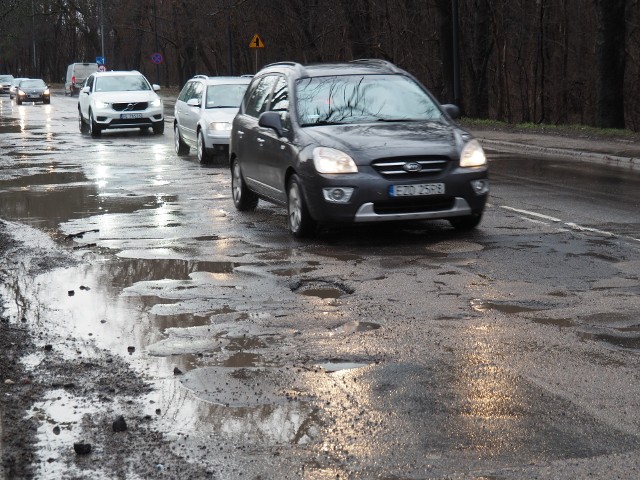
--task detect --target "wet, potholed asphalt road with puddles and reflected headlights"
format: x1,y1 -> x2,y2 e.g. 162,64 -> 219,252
0,91 -> 640,479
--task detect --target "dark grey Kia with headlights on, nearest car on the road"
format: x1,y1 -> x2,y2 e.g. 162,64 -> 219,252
229,60 -> 489,237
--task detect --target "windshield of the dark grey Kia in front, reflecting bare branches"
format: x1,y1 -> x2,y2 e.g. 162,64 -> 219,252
296,75 -> 442,126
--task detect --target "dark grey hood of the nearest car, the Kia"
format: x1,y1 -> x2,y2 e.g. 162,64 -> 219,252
303,121 -> 464,164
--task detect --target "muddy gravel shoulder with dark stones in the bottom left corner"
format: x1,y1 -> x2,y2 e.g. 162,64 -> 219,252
0,220 -> 211,479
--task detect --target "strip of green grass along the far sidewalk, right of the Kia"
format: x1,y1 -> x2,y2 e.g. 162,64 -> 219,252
459,117 -> 640,141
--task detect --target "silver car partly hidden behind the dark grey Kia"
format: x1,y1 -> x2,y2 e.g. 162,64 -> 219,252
173,75 -> 251,164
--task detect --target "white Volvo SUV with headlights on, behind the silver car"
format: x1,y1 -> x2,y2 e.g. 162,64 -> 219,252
78,71 -> 164,137
